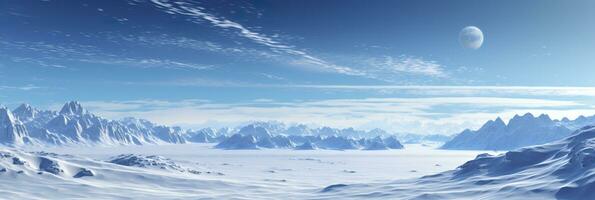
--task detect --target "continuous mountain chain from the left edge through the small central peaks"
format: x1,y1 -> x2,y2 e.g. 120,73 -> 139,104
0,101 -> 402,149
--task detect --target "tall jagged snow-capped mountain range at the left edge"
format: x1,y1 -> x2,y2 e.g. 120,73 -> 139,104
0,101 -> 186,145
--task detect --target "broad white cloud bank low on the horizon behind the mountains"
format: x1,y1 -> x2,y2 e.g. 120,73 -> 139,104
78,97 -> 595,134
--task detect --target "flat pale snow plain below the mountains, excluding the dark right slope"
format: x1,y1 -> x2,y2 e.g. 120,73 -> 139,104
0,144 -> 482,199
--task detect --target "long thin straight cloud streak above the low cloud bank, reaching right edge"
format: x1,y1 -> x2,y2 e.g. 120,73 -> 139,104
121,76 -> 595,97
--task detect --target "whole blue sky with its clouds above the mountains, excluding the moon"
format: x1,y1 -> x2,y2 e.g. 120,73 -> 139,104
0,0 -> 595,134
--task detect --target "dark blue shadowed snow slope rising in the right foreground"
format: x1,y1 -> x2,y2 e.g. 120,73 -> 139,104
319,126 -> 595,200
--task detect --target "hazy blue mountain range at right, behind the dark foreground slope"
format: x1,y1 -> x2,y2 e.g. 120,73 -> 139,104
442,113 -> 595,150
